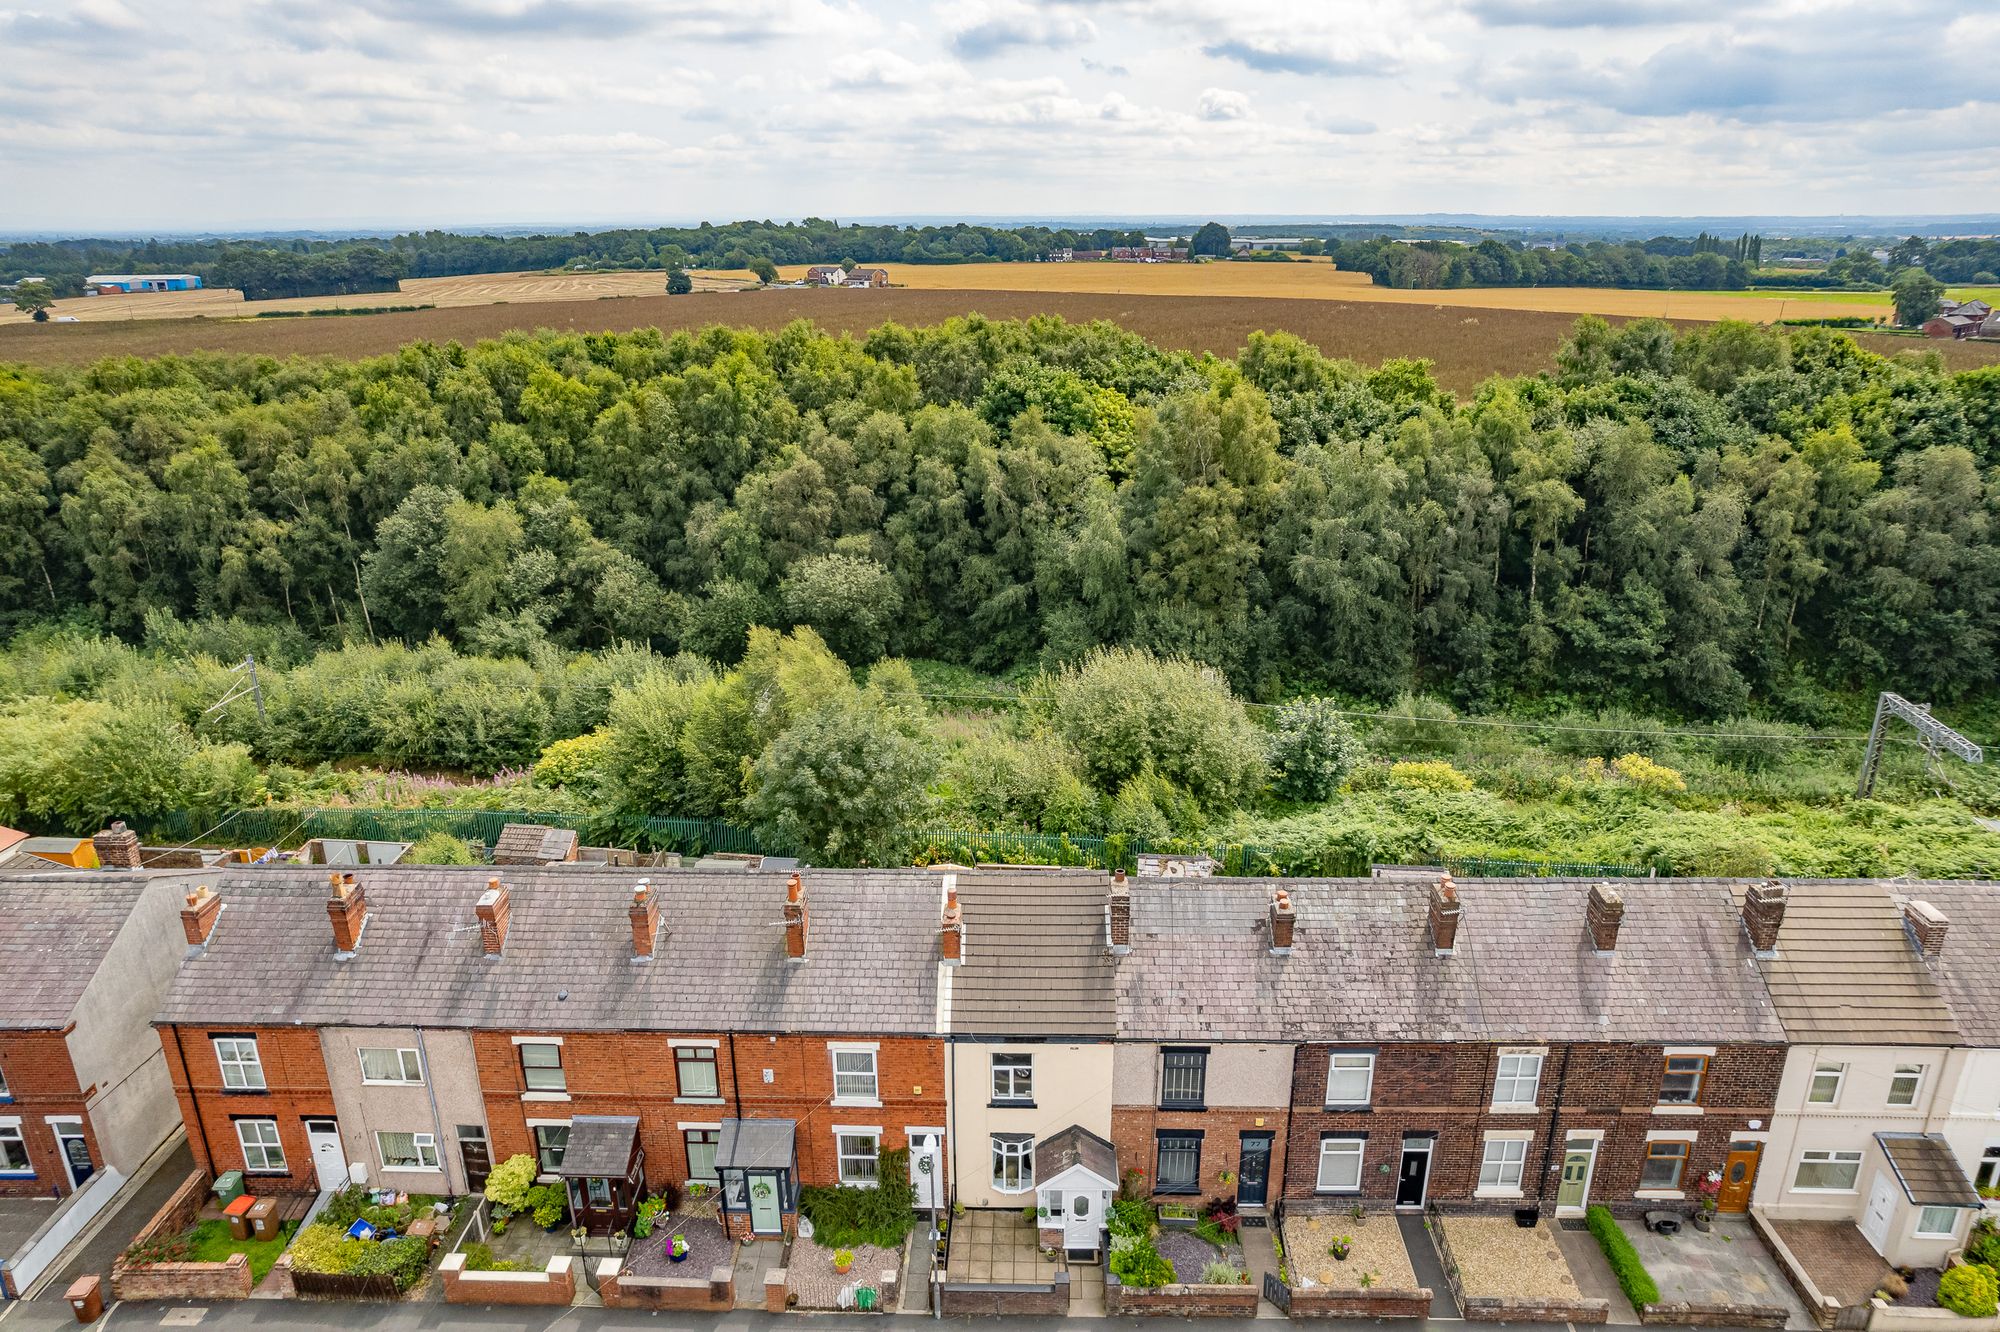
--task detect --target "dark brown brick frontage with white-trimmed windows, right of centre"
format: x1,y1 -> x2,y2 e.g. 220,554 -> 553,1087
1284,1040 -> 1786,1212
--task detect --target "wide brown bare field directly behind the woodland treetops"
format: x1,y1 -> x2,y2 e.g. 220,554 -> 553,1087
0,286 -> 2000,394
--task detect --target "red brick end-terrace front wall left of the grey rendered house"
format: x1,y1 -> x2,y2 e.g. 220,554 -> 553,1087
160,1024 -> 336,1194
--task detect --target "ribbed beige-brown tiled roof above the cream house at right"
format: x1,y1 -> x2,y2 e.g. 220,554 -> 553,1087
1738,880 -> 1970,1046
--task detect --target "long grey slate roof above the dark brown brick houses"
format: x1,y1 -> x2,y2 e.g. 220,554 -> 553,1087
1118,878 -> 1784,1042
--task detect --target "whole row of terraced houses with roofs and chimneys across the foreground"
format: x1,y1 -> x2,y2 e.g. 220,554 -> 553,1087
0,832 -> 2000,1304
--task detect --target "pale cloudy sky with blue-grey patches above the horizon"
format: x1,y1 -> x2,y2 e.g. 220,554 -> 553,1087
0,0 -> 2000,232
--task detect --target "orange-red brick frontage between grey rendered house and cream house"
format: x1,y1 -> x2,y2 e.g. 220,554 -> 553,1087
472,1030 -> 944,1184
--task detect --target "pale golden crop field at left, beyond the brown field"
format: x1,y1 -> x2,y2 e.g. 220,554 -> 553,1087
0,272 -> 756,324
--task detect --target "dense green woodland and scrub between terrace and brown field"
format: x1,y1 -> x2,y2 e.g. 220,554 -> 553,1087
0,318 -> 2000,874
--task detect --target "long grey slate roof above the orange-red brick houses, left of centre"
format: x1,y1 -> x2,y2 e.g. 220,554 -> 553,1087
148,864 -> 942,1034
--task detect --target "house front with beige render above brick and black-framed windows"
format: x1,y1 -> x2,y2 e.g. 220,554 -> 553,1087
1112,1040 -> 1294,1204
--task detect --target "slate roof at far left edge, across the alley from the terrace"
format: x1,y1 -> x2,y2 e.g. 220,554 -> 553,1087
0,874 -> 182,1032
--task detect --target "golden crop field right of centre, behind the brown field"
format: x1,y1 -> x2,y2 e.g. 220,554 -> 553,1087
778,262 -> 1894,322
